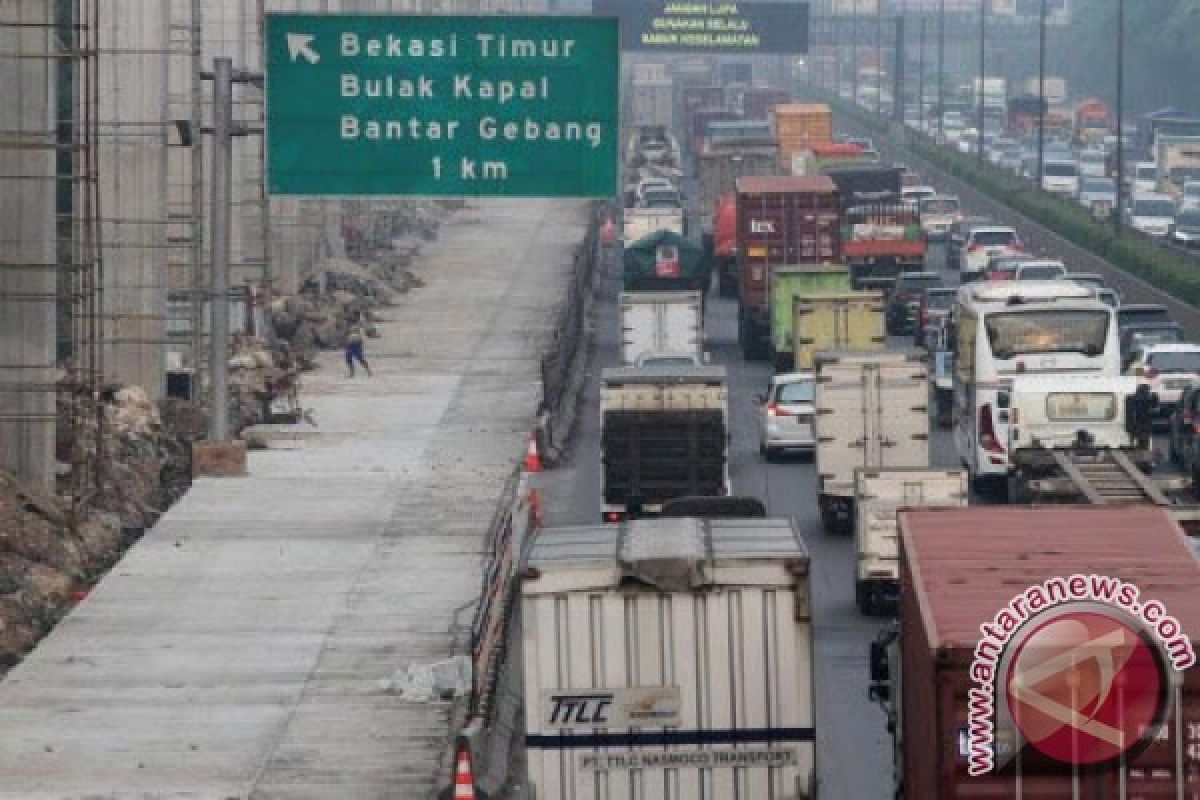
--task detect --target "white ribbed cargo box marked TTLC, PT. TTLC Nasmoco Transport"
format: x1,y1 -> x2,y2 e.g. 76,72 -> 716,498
521,518 -> 816,800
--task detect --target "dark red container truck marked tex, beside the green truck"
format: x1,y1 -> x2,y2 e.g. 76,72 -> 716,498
737,175 -> 841,359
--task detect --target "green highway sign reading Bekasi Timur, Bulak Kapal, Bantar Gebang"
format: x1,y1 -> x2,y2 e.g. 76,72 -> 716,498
266,13 -> 620,197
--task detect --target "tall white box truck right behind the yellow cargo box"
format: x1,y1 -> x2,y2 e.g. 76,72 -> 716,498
816,350 -> 929,533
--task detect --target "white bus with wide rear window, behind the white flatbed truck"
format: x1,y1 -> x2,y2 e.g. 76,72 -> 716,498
952,281 -> 1121,492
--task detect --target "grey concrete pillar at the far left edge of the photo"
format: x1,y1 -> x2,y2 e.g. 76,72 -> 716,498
0,0 -> 56,488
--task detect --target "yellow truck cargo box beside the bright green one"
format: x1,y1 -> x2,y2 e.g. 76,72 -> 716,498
792,291 -> 888,372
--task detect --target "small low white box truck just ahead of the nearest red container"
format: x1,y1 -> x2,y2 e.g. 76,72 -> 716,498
854,467 -> 971,615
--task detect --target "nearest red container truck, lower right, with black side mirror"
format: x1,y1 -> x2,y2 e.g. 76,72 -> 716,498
871,506 -> 1200,800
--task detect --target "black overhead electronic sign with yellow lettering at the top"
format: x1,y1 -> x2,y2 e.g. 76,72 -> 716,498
592,0 -> 809,55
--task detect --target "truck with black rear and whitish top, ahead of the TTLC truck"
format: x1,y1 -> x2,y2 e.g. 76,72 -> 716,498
600,366 -> 731,522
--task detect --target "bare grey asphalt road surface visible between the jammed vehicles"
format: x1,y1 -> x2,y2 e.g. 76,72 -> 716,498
541,241 -> 956,800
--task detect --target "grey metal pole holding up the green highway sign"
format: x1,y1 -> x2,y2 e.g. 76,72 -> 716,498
209,59 -> 233,441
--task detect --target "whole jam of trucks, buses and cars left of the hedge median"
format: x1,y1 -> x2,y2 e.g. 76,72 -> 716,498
522,61 -> 1200,798
